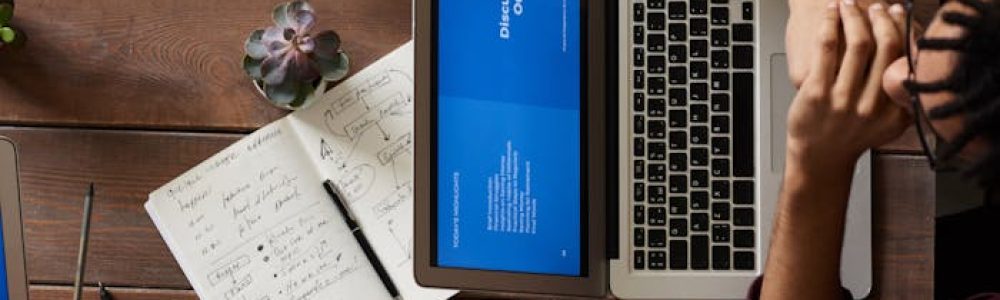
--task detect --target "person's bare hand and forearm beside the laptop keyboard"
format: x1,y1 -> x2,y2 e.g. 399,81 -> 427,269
761,0 -> 910,300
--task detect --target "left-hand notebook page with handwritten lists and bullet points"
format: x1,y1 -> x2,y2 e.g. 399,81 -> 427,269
145,119 -> 389,300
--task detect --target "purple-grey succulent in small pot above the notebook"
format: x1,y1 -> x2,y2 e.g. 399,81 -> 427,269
243,1 -> 350,110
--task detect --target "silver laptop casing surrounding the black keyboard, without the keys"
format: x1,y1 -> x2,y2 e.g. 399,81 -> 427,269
609,0 -> 872,299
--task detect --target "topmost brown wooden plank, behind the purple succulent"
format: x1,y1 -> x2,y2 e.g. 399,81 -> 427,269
0,0 -> 411,131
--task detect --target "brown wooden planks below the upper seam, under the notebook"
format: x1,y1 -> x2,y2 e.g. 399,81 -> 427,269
0,127 -> 934,299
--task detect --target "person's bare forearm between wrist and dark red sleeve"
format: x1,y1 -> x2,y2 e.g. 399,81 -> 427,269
761,155 -> 854,300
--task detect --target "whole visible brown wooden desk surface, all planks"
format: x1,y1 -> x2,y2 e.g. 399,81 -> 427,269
0,0 -> 934,300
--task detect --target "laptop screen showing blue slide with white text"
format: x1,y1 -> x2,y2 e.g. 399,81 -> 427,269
415,0 -> 607,295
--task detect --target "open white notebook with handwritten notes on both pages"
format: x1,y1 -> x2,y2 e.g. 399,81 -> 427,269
146,42 -> 454,300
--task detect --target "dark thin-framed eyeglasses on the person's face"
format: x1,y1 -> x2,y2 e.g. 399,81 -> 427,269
904,0 -> 958,171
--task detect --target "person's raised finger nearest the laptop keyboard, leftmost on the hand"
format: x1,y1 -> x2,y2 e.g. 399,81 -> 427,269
803,1 -> 840,93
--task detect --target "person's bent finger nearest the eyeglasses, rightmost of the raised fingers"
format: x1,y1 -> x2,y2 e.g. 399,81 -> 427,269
858,3 -> 903,112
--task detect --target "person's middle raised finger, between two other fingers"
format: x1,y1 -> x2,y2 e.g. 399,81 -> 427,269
831,0 -> 875,108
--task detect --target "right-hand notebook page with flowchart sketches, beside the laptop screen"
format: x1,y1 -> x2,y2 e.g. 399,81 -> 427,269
289,42 -> 456,300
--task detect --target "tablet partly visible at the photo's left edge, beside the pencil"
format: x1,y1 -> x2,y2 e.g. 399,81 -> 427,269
0,136 -> 28,299
